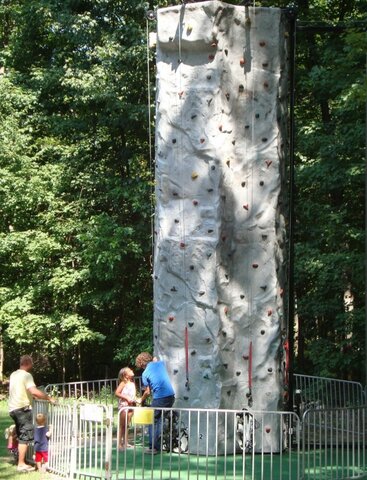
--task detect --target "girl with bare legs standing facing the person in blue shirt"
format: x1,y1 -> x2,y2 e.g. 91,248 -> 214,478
115,367 -> 136,450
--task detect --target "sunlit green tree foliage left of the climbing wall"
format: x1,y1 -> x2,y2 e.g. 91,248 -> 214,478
0,0 -> 151,381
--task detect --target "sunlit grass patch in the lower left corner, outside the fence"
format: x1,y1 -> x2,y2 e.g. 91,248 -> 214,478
0,400 -> 56,480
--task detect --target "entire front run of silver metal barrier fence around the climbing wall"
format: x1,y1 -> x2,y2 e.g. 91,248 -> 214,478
29,401 -> 367,480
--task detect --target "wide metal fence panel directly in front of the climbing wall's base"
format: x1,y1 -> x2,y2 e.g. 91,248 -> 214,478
114,408 -> 300,480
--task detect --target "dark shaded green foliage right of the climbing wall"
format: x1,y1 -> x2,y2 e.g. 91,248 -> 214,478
295,2 -> 367,380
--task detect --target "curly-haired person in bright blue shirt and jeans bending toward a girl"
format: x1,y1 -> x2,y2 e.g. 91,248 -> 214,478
135,352 -> 175,454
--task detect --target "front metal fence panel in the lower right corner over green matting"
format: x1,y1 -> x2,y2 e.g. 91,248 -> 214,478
302,407 -> 367,480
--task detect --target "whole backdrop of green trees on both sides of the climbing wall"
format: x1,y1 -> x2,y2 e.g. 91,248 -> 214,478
0,0 -> 367,381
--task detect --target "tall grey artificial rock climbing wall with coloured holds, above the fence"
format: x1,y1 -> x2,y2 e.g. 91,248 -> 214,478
154,1 -> 288,451
